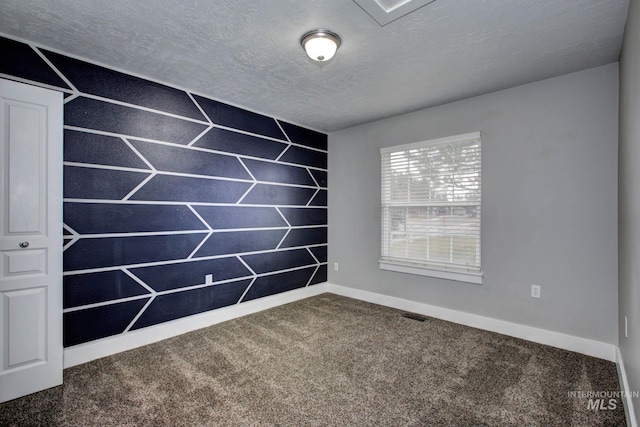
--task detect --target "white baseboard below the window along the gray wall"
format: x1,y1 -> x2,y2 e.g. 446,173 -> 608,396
326,283 -> 617,362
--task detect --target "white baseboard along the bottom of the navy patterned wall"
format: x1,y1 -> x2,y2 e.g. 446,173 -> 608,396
64,283 -> 327,368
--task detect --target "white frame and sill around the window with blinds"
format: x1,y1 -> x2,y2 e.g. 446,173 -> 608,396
378,131 -> 483,284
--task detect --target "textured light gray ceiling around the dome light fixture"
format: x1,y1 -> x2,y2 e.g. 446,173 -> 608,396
0,0 -> 629,132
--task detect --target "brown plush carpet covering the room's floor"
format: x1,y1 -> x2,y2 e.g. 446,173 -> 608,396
0,294 -> 625,426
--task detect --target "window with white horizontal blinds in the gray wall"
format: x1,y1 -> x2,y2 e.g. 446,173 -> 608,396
380,132 -> 482,283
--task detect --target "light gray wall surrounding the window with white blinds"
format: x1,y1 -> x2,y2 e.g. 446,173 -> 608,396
328,63 -> 618,344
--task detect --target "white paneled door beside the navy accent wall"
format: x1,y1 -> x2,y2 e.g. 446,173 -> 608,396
0,80 -> 63,402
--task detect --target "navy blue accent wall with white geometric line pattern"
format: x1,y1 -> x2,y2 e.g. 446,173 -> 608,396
0,37 -> 327,347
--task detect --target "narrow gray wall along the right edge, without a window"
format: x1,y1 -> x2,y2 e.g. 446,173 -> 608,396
618,1 -> 640,420
